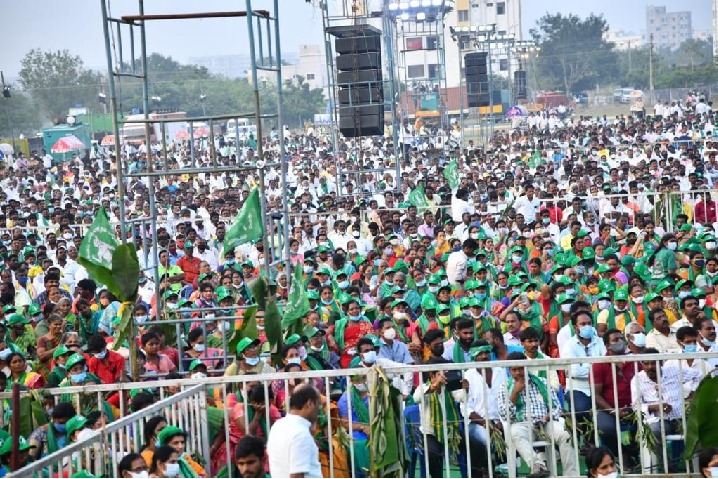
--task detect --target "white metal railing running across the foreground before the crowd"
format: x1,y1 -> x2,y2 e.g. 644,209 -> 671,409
7,353 -> 718,477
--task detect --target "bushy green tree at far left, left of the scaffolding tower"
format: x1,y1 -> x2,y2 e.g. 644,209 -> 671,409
19,50 -> 103,118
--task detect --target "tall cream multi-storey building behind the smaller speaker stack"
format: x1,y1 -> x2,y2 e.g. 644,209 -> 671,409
444,0 -> 521,87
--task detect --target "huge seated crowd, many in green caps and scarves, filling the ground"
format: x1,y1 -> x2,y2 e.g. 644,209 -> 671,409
0,94 -> 718,477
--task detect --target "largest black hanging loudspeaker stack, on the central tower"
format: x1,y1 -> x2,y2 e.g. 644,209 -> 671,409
334,31 -> 384,138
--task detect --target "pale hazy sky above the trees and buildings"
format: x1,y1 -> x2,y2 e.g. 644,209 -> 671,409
0,0 -> 712,77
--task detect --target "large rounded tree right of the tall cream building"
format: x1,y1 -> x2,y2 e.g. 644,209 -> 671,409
530,13 -> 616,92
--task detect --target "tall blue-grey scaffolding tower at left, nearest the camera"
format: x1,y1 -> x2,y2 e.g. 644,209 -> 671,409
101,0 -> 291,379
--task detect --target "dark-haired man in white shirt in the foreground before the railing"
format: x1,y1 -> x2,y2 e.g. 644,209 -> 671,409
267,384 -> 322,477
